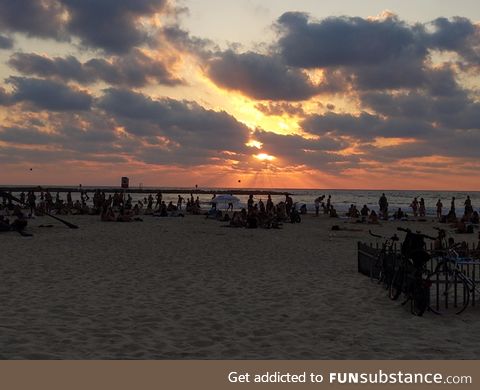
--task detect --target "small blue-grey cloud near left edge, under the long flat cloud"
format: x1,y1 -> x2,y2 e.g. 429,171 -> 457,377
8,77 -> 93,111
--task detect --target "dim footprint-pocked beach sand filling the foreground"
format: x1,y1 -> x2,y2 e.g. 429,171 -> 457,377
0,216 -> 480,359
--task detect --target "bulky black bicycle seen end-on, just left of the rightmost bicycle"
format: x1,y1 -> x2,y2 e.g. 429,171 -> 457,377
389,227 -> 435,316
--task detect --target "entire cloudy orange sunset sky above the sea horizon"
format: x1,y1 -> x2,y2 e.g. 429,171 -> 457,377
0,0 -> 480,190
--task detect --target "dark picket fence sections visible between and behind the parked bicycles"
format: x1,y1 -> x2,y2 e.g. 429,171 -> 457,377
357,242 -> 480,307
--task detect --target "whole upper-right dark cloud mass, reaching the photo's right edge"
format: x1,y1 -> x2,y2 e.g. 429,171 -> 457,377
276,12 -> 480,90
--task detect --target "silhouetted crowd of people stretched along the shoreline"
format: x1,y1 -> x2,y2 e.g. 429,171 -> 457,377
0,189 -> 480,233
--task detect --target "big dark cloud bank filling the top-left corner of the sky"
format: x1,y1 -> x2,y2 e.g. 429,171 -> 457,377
0,0 -> 167,53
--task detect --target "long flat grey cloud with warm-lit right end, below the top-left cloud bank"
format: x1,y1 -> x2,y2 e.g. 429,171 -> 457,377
9,49 -> 182,87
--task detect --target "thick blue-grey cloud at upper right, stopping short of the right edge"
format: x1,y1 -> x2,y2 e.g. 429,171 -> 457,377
278,12 -> 426,68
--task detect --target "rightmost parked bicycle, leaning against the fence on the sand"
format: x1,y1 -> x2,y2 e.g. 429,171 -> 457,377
428,244 -> 480,315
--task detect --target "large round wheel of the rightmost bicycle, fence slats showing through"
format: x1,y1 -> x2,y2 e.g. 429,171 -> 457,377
427,268 -> 470,315
